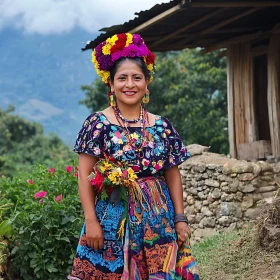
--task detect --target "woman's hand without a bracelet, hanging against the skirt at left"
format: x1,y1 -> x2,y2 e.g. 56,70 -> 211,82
86,219 -> 104,251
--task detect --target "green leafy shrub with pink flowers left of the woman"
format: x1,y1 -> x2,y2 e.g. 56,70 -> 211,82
0,165 -> 83,280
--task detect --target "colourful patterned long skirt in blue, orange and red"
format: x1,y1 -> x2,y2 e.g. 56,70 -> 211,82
68,177 -> 199,280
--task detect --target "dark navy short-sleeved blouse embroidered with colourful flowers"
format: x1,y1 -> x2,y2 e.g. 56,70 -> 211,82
74,112 -> 190,176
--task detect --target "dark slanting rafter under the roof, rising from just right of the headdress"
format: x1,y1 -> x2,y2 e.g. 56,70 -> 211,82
150,9 -> 227,48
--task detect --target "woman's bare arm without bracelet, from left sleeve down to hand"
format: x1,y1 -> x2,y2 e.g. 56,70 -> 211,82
78,153 -> 104,250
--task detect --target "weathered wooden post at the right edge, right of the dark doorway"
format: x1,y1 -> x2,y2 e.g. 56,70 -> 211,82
267,34 -> 280,157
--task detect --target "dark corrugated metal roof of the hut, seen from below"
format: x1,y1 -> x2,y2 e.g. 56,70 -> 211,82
84,0 -> 280,51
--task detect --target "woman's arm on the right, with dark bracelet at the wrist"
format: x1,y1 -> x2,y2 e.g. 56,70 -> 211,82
164,166 -> 191,246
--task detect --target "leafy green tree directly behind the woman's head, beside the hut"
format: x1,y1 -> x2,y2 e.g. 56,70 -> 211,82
81,49 -> 228,153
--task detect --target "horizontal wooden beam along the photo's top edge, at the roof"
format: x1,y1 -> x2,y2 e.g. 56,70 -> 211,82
190,1 -> 280,8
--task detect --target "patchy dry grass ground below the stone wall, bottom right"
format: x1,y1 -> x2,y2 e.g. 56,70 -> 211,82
192,226 -> 280,280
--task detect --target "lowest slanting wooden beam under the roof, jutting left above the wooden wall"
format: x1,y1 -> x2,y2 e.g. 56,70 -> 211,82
201,31 -> 263,54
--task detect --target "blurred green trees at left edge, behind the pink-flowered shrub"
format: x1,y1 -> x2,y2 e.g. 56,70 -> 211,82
0,107 -> 71,176
